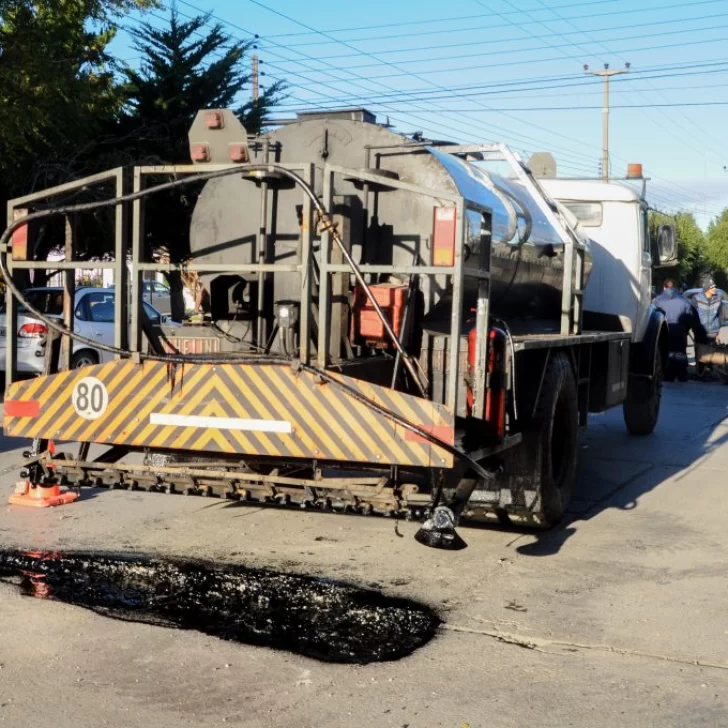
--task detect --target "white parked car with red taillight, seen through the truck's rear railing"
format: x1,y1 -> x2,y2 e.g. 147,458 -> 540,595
0,287 -> 170,374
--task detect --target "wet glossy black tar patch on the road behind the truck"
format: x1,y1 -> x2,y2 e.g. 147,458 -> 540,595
0,551 -> 440,664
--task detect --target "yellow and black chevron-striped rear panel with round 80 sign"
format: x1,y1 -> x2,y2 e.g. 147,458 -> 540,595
4,360 -> 454,467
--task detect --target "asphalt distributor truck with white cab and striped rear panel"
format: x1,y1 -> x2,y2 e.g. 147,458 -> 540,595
0,109 -> 676,548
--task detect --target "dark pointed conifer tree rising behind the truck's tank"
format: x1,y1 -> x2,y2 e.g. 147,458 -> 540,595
118,5 -> 283,320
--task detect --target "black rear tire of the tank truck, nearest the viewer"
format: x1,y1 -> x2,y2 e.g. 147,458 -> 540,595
514,352 -> 579,527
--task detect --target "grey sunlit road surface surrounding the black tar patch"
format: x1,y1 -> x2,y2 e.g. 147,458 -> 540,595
0,382 -> 728,728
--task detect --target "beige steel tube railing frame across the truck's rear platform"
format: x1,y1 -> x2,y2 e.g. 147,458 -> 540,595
6,159 -> 490,420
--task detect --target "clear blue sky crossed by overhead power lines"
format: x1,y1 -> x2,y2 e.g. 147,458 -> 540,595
114,0 -> 728,225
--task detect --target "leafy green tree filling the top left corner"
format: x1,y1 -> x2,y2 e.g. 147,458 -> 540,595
0,0 -> 154,198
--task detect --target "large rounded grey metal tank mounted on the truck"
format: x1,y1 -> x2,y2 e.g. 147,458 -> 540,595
190,110 -> 592,319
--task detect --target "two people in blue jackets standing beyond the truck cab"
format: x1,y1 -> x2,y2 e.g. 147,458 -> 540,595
654,277 -> 728,382
